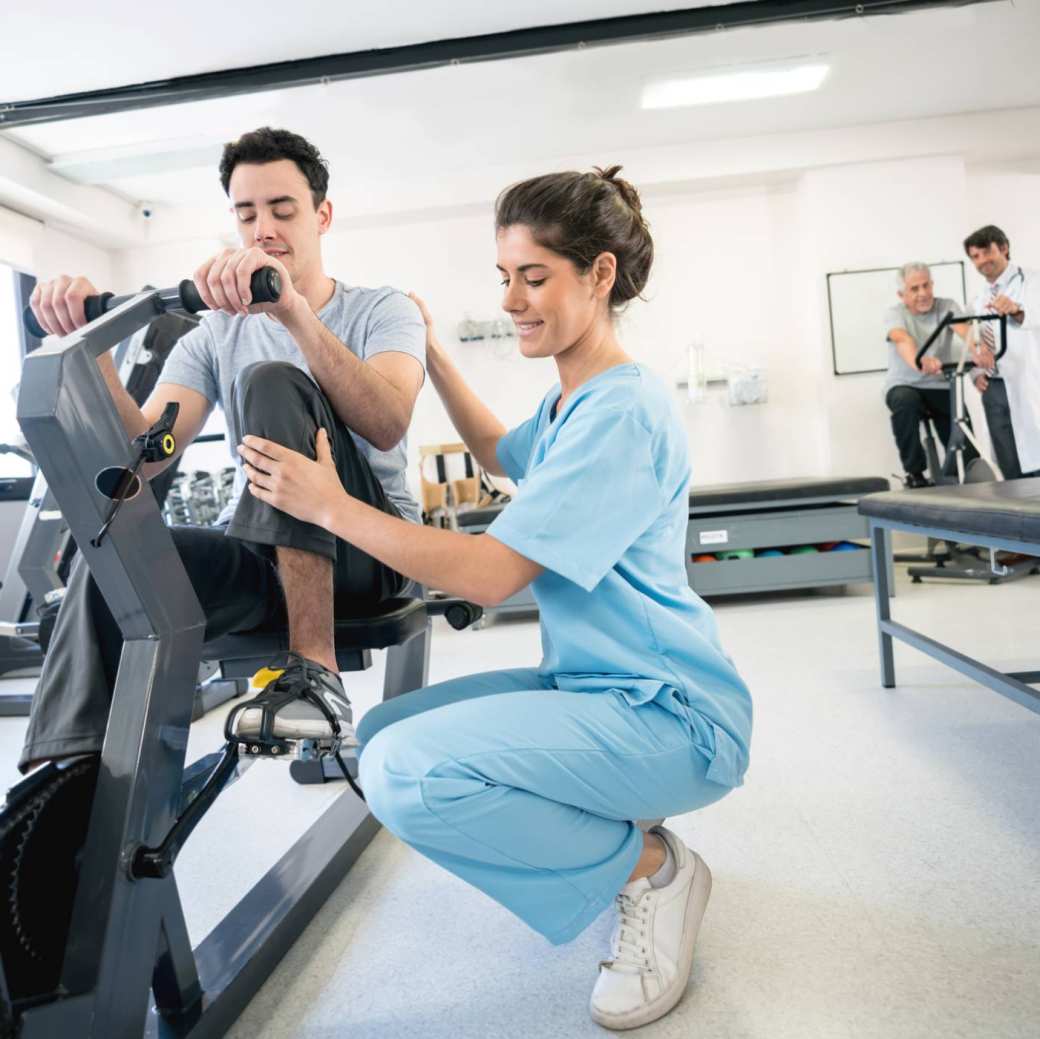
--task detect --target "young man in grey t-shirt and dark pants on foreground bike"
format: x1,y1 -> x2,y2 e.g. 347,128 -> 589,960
0,128 -> 425,989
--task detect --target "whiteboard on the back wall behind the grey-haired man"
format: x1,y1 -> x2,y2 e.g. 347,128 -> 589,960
827,260 -> 965,375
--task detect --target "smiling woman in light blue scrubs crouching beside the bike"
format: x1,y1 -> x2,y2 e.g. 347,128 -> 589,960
239,167 -> 751,1029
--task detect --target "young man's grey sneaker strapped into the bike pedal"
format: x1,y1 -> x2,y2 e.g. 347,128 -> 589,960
230,653 -> 358,747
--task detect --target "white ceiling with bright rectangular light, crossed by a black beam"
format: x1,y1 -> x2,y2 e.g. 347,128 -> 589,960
0,0 -> 1040,232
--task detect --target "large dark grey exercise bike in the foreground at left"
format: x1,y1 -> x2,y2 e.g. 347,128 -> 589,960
0,268 -> 479,1039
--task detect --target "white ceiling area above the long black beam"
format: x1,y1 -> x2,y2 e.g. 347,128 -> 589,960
0,0 -> 730,102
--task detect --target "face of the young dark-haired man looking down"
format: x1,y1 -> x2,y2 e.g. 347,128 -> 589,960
228,159 -> 332,284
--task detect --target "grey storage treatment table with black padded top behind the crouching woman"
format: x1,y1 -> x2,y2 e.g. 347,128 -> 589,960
686,476 -> 889,595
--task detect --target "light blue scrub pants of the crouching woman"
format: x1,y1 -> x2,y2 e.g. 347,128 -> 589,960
358,669 -> 730,944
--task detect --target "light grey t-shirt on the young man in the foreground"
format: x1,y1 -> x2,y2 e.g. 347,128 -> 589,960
159,282 -> 426,523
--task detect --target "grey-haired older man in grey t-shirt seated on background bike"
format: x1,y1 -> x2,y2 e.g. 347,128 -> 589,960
885,263 -> 976,489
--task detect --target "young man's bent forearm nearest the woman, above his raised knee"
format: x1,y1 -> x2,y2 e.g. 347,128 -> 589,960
283,307 -> 412,450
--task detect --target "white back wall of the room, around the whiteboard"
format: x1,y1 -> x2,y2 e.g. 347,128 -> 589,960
101,156 -> 1040,499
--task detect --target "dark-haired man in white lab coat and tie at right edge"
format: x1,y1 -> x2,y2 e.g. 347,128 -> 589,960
964,225 -> 1040,479
